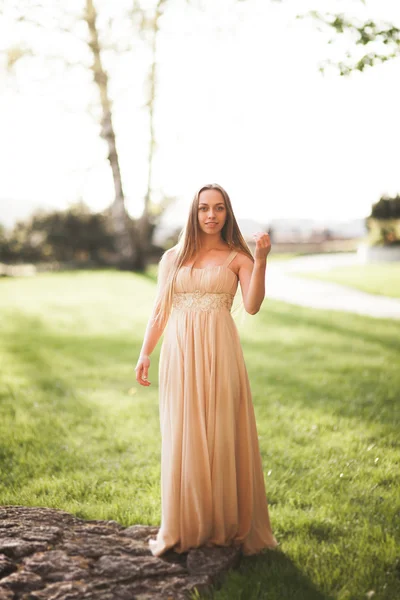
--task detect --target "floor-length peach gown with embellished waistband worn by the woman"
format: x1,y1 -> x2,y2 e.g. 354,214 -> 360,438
149,251 -> 278,556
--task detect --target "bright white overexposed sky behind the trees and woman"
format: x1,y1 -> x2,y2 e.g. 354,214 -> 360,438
0,0 -> 400,229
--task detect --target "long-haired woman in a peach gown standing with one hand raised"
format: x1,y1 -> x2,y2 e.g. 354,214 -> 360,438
135,184 -> 278,556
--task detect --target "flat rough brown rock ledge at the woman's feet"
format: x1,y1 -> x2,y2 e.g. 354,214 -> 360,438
0,506 -> 241,600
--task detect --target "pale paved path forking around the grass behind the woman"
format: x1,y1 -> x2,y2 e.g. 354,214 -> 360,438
266,253 -> 400,319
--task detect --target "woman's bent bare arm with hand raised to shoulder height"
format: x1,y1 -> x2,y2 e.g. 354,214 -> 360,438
238,233 -> 271,315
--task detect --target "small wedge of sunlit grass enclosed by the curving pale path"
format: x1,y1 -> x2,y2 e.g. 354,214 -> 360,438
296,263 -> 400,298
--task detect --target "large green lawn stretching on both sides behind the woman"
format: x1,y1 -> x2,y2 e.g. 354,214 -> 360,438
0,271 -> 400,600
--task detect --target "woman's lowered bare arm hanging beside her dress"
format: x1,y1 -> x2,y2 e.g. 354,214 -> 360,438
135,252 -> 172,386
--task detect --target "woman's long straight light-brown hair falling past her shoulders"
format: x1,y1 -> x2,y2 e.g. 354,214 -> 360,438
155,183 -> 254,322
